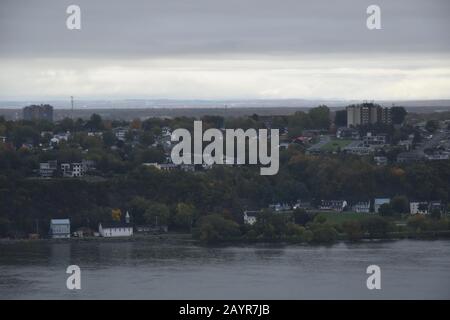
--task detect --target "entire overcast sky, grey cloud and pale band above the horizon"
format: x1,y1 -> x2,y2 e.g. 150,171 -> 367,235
0,0 -> 450,99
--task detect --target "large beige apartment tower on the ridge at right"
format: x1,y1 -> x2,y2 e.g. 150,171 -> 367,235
347,103 -> 391,127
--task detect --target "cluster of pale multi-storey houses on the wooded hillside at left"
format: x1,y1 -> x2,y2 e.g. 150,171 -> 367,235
39,159 -> 95,178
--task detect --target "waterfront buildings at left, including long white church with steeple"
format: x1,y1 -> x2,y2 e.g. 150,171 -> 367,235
49,212 -> 168,239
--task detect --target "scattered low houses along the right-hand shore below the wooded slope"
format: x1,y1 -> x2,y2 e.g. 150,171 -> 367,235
243,198 -> 445,225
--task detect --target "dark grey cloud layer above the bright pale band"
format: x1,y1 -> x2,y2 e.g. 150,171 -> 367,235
0,0 -> 450,58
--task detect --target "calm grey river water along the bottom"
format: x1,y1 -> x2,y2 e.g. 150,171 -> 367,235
0,239 -> 450,299
